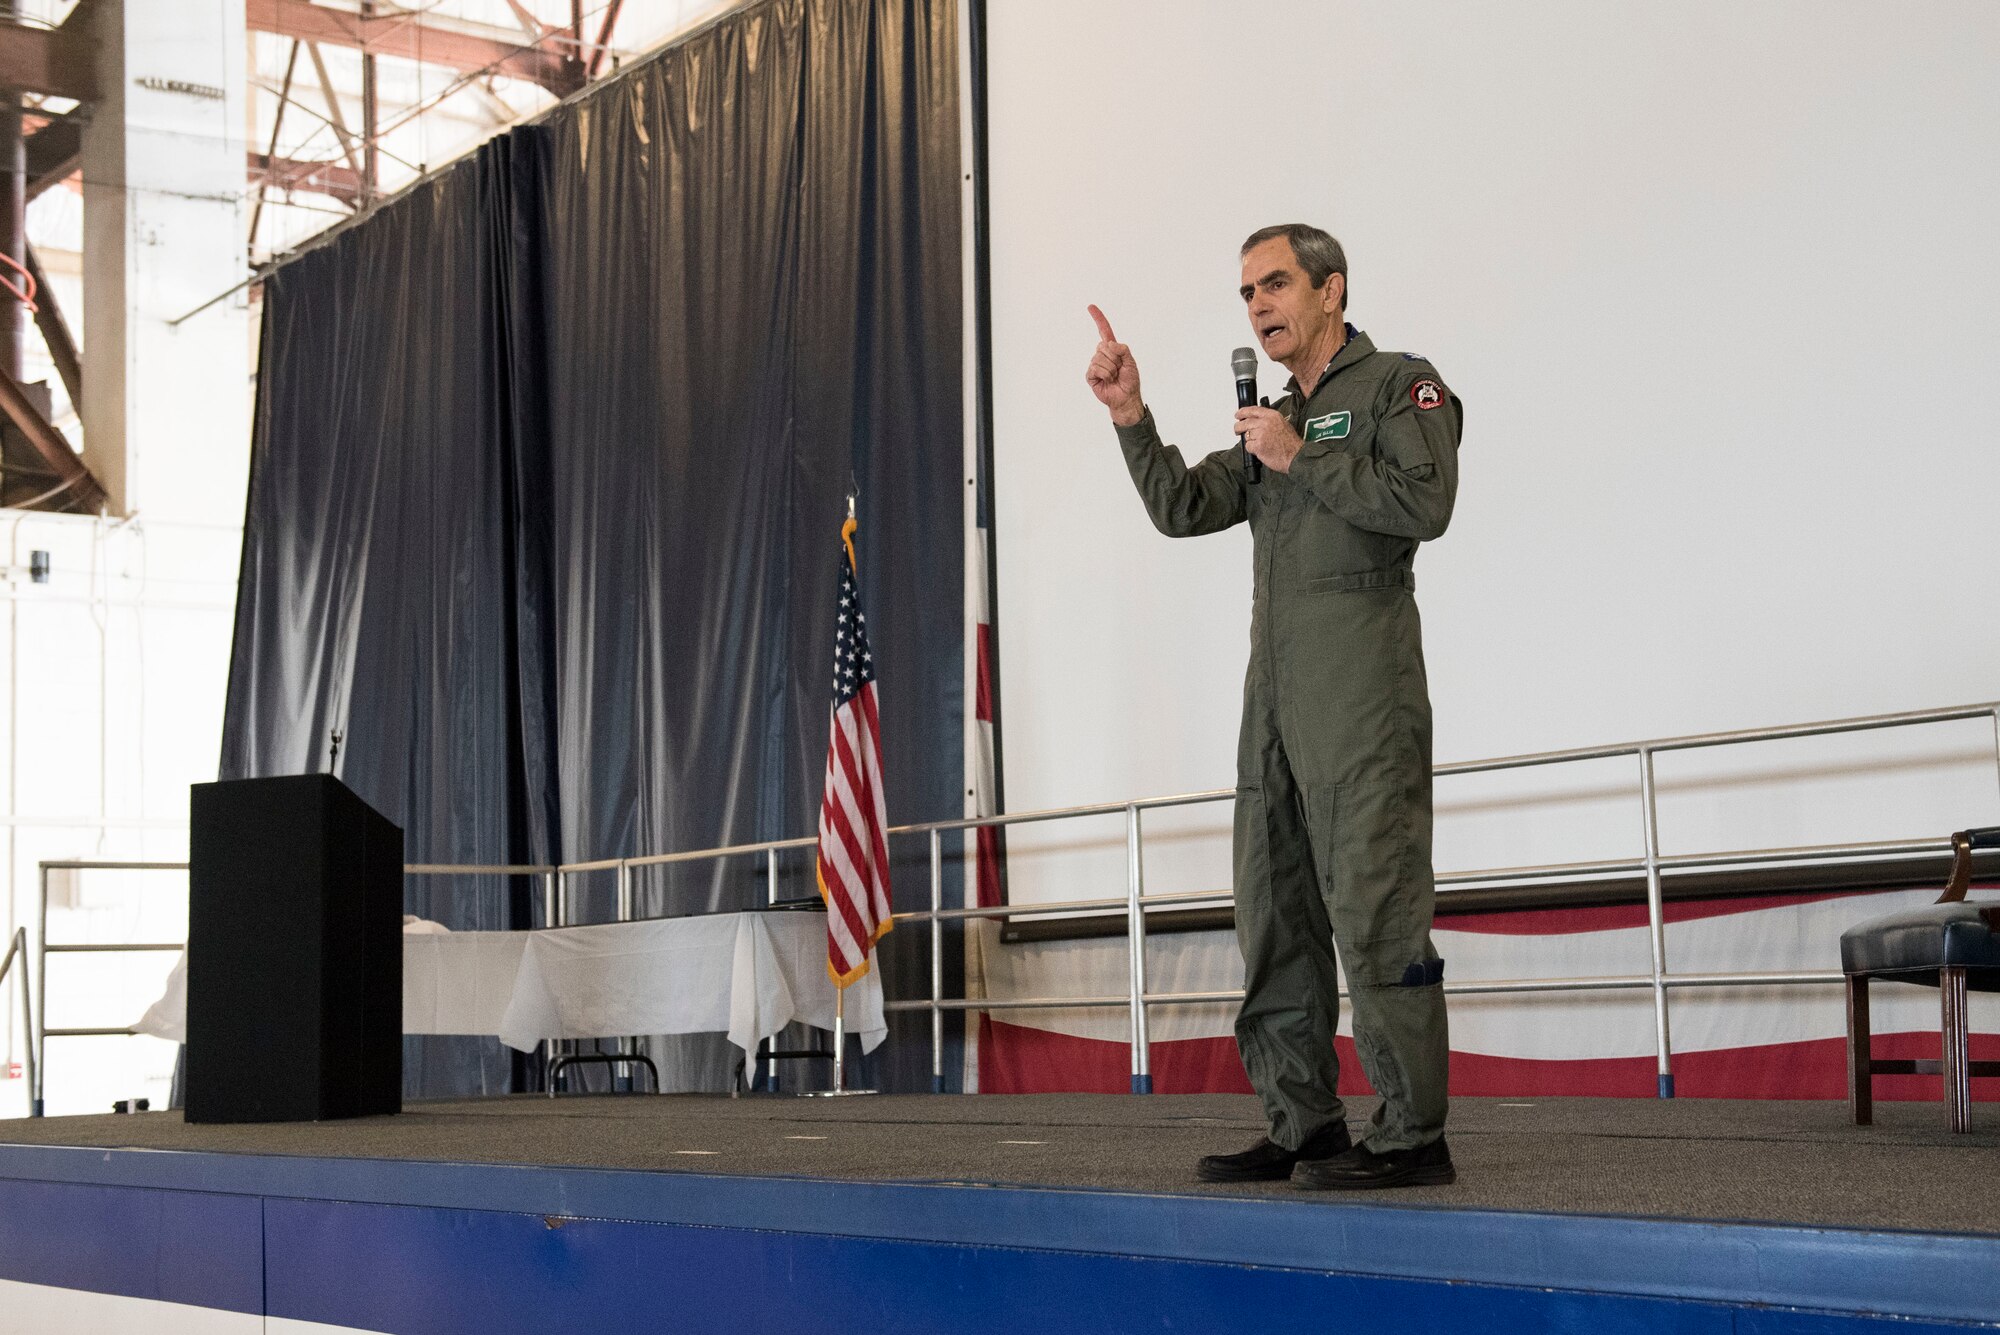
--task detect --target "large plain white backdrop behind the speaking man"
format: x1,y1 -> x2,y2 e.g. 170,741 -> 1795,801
990,0 -> 2000,897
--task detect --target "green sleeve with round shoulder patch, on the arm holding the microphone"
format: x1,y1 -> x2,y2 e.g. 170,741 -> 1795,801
1292,362 -> 1464,542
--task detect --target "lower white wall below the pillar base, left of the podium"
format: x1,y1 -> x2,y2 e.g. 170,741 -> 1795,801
0,510 -> 240,1117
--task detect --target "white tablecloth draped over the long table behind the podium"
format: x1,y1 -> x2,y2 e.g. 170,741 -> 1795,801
134,911 -> 888,1051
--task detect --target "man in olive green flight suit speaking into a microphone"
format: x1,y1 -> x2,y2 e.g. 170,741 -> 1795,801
1086,224 -> 1462,1189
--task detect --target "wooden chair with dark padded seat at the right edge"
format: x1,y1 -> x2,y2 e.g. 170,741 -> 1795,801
1840,825 -> 2000,1131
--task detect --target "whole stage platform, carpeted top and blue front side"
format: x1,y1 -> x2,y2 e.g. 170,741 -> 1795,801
0,1095 -> 2000,1335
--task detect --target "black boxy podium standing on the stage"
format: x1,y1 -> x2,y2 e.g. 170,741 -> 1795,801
186,773 -> 402,1121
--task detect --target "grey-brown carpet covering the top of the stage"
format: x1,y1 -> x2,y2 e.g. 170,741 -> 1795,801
0,1095 -> 2000,1233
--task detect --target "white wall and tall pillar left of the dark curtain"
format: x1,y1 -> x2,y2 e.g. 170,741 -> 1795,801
0,0 -> 252,1117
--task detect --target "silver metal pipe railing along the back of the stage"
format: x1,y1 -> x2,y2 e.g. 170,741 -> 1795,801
36,701 -> 2000,1105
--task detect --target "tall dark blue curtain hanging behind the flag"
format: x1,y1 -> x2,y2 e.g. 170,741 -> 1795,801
222,0 -> 964,1095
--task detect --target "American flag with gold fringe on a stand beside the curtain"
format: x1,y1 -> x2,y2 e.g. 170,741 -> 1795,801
820,516 -> 892,987
